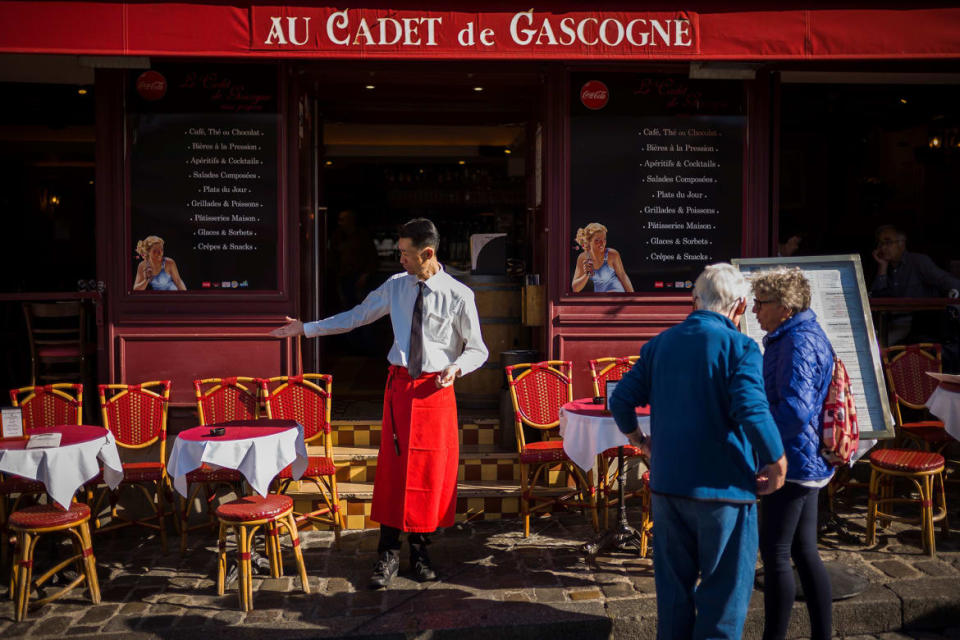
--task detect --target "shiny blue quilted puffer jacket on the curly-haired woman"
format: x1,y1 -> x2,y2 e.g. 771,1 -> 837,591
763,309 -> 833,481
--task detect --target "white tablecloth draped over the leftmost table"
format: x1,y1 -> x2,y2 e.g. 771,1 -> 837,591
0,426 -> 123,509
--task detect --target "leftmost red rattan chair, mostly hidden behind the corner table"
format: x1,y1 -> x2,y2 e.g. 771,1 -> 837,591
0,382 -> 83,563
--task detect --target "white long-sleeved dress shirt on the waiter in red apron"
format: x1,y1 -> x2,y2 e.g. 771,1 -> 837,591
303,269 -> 489,375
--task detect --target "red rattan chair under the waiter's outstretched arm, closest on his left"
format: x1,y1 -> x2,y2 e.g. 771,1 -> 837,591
260,373 -> 343,545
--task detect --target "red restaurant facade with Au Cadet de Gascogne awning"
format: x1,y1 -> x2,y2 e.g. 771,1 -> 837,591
0,0 -> 960,407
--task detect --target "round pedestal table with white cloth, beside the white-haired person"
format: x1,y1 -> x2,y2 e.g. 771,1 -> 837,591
560,398 -> 650,556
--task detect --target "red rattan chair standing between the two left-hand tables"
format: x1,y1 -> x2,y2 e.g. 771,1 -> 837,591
93,380 -> 170,552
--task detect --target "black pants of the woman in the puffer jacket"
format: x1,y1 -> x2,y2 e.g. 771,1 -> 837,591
760,482 -> 832,640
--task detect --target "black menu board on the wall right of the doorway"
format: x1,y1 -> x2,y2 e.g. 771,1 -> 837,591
570,73 -> 746,293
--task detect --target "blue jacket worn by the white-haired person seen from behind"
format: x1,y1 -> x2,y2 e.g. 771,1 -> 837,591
609,311 -> 783,502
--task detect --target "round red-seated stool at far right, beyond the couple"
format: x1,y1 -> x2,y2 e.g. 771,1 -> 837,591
867,449 -> 950,557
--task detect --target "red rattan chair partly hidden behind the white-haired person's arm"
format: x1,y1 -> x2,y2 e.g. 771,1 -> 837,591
590,356 -> 653,557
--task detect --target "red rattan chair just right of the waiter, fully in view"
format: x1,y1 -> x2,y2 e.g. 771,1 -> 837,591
506,360 -> 597,538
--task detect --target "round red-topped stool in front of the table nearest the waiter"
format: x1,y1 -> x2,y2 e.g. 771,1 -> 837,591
217,494 -> 310,611
